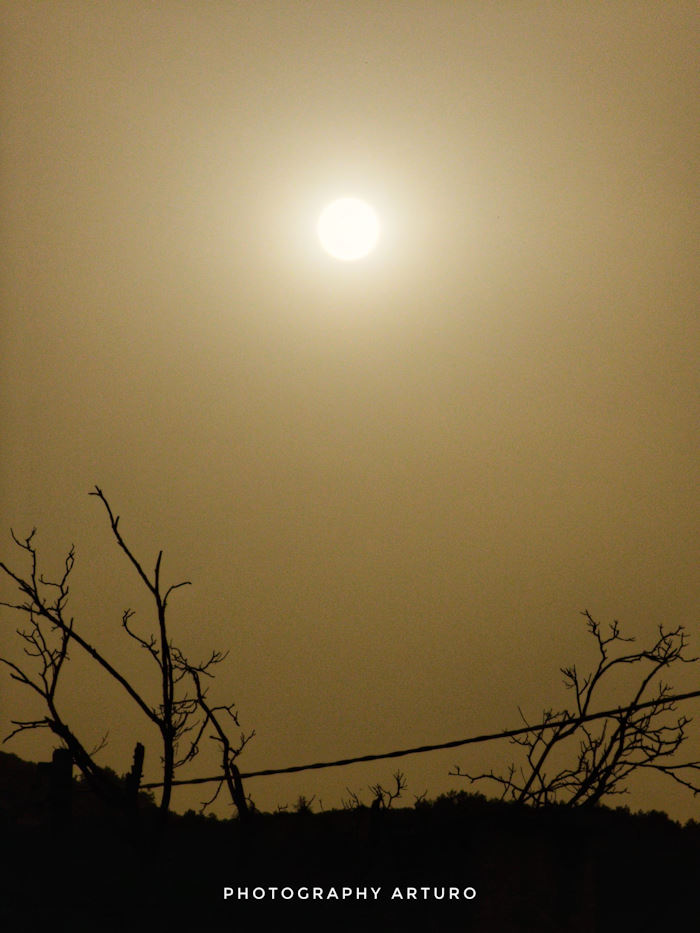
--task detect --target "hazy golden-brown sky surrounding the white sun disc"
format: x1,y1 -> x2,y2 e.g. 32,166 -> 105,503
0,0 -> 700,818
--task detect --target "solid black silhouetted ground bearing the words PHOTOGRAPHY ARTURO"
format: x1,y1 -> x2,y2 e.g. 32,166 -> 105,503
0,748 -> 700,933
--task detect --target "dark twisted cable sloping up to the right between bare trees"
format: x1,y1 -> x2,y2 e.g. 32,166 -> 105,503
141,690 -> 700,790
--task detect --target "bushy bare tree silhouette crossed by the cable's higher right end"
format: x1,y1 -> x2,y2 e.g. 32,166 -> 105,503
451,612 -> 700,807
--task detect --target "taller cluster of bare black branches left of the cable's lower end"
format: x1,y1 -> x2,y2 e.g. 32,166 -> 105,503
0,487 -> 254,814
